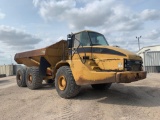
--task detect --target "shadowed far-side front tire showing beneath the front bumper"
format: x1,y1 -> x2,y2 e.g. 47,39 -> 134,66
91,83 -> 112,90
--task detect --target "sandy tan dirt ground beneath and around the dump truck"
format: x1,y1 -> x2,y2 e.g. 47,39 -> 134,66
0,74 -> 160,120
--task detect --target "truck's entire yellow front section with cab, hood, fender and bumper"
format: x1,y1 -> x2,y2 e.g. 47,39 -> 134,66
67,30 -> 146,85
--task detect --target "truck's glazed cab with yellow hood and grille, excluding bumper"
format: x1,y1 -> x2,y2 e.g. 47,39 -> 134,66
67,31 -> 143,72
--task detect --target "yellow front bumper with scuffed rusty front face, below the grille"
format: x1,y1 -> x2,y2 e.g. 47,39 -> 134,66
75,71 -> 147,85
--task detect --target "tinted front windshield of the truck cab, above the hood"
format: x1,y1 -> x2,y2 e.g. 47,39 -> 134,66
88,32 -> 109,46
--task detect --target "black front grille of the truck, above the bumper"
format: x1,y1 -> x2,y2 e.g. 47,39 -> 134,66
124,59 -> 142,71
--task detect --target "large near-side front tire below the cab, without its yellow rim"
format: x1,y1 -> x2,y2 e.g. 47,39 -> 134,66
55,66 -> 81,99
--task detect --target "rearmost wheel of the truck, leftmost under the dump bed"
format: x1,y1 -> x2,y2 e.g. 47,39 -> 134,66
16,68 -> 27,87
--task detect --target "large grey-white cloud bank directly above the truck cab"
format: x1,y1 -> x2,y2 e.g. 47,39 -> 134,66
33,0 -> 142,31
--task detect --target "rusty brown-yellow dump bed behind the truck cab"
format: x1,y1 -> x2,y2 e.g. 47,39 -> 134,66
14,40 -> 67,67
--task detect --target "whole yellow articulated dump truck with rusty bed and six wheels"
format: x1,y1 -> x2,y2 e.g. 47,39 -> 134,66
15,30 -> 146,98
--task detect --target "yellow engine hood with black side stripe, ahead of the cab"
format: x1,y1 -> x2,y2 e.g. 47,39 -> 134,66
92,46 -> 142,71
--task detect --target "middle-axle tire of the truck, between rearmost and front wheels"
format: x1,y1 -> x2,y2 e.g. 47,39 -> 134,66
26,67 -> 43,90
